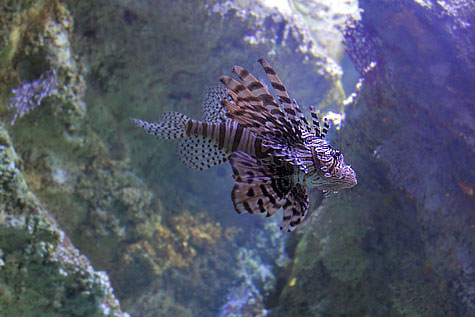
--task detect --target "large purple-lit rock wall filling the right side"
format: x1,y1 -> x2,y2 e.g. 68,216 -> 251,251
271,0 -> 475,316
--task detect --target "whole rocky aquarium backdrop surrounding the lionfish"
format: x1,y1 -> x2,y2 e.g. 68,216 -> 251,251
0,0 -> 475,316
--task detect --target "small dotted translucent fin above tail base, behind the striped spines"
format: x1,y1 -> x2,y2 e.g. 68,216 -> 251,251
202,85 -> 229,123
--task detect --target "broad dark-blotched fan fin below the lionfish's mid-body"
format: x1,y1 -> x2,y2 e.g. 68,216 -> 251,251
230,152 -> 290,216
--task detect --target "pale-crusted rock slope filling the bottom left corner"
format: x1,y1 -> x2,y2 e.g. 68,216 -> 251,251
0,120 -> 127,316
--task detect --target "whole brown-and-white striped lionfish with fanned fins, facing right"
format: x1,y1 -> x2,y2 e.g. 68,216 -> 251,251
132,59 -> 357,231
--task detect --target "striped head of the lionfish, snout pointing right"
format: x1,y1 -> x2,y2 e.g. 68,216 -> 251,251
309,145 -> 357,192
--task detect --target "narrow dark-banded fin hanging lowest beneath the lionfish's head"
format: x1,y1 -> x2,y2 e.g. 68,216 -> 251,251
280,184 -> 309,232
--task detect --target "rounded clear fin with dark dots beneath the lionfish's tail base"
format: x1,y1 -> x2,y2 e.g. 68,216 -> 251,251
177,136 -> 229,170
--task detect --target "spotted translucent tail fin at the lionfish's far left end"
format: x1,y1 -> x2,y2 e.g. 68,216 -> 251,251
131,112 -> 190,140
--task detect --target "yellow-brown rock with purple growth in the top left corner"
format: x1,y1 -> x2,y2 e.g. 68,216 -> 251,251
0,0 -> 86,132
